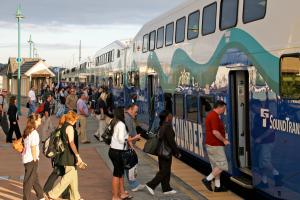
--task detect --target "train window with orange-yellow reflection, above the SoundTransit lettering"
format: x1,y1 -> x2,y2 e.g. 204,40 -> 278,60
280,54 -> 300,99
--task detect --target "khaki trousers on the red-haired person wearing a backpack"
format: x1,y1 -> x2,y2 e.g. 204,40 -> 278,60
48,166 -> 80,200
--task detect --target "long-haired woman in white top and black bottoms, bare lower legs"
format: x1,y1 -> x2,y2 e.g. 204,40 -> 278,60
108,108 -> 132,200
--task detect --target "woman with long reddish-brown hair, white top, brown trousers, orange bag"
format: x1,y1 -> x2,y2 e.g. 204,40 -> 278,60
22,114 -> 45,200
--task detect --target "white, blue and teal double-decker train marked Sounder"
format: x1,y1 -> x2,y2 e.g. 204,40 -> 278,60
63,0 -> 300,199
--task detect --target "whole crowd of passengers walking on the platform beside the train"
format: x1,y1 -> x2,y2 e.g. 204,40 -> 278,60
0,81 -> 229,200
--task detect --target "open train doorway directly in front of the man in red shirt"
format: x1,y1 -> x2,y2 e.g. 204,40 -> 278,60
229,70 -> 252,187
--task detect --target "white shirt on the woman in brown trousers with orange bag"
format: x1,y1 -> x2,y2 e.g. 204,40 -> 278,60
22,130 -> 40,164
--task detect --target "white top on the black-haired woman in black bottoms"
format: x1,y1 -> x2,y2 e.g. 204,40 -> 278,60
110,121 -> 128,150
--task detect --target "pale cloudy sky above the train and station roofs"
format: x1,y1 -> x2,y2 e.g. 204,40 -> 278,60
0,0 -> 185,67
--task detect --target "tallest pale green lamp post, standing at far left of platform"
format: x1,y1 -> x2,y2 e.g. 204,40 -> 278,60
16,6 -> 24,115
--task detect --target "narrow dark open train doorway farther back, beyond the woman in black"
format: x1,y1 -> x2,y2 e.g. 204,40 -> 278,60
147,75 -> 157,127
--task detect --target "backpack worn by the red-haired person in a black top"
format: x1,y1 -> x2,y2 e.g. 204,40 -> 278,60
43,129 -> 65,158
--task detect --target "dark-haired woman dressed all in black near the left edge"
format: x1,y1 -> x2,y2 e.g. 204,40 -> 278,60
6,96 -> 22,143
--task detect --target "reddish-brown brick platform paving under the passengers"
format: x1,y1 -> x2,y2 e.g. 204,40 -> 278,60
0,108 -> 204,200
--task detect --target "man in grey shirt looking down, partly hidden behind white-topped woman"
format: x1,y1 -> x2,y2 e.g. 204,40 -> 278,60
125,104 -> 145,192
